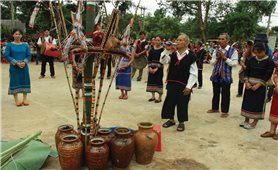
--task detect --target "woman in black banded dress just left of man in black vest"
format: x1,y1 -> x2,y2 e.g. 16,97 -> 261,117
147,36 -> 164,103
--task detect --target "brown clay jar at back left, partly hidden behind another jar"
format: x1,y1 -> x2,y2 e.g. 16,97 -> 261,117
55,125 -> 77,150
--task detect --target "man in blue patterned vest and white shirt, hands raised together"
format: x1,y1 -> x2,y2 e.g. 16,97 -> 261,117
207,33 -> 238,118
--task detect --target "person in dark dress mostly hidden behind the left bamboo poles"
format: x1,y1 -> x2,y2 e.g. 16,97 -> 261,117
71,48 -> 83,98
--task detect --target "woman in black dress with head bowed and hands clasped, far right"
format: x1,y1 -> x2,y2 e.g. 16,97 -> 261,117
240,43 -> 274,129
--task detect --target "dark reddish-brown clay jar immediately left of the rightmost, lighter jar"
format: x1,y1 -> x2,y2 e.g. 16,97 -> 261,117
111,127 -> 135,168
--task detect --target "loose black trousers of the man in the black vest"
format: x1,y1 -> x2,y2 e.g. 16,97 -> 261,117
161,83 -> 190,122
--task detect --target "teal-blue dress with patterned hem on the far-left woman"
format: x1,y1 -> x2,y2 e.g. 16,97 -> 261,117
4,43 -> 32,95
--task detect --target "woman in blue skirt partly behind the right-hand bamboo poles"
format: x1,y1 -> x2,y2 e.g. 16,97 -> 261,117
116,44 -> 134,100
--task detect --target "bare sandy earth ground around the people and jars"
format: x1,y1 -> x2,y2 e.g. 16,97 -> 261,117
1,62 -> 278,170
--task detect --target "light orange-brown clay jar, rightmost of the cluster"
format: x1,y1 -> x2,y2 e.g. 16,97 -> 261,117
134,122 -> 158,165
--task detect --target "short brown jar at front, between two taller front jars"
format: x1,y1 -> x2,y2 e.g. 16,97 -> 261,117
86,137 -> 109,170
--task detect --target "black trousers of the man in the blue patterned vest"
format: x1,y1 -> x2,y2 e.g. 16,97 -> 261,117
212,82 -> 231,113
